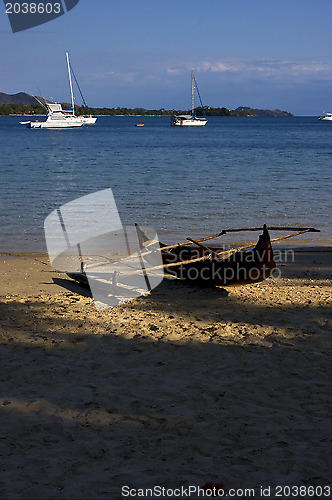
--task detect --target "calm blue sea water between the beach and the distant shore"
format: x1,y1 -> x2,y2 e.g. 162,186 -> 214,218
0,117 -> 332,251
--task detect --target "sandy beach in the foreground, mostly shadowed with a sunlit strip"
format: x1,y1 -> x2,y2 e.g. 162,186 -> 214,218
0,252 -> 332,499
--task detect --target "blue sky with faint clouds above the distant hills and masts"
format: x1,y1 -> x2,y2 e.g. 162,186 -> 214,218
0,0 -> 332,115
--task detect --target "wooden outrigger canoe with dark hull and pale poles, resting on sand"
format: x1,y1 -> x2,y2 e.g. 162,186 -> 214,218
67,224 -> 319,293
